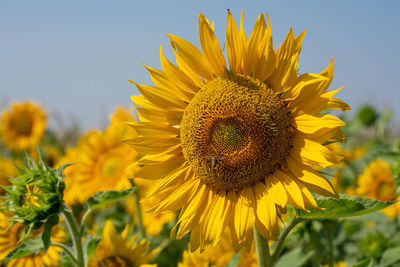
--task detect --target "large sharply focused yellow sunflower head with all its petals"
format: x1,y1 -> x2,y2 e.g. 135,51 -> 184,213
128,11 -> 349,251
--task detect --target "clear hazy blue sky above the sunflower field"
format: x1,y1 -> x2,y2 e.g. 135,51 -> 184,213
0,0 -> 400,128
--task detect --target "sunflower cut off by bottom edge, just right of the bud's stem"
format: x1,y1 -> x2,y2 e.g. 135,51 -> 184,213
88,221 -> 158,267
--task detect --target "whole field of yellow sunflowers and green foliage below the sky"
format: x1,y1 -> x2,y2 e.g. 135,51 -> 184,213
0,10 -> 400,267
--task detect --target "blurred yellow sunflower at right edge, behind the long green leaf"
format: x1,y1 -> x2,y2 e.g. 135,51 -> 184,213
356,159 -> 400,218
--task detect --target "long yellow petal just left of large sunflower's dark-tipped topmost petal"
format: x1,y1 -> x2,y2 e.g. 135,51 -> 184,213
199,13 -> 227,77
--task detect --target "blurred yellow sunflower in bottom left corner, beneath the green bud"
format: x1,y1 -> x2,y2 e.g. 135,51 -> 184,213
0,212 -> 67,267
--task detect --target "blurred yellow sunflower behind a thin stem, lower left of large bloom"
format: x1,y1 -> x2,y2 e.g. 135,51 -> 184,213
126,179 -> 176,236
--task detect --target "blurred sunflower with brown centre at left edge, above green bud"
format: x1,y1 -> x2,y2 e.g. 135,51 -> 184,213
0,101 -> 46,151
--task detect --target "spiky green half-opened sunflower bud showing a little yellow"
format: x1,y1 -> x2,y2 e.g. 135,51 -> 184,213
3,158 -> 66,230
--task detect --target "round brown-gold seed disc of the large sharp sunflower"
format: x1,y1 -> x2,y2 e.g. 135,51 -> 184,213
181,76 -> 293,191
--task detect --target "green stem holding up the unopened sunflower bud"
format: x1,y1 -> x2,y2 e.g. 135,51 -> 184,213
61,204 -> 85,267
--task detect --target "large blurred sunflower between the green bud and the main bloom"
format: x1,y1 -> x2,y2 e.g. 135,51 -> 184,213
59,109 -> 137,204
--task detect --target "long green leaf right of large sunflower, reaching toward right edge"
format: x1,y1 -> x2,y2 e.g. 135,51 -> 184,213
297,195 -> 397,219
